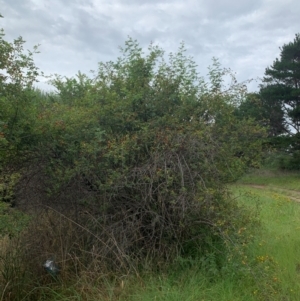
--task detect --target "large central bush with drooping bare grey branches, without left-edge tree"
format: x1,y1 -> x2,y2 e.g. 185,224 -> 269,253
27,39 -> 264,267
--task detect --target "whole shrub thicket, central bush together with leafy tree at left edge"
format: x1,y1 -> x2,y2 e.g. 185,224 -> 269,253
0,29 -> 265,286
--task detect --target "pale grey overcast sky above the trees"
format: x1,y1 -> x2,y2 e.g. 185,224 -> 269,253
0,0 -> 300,90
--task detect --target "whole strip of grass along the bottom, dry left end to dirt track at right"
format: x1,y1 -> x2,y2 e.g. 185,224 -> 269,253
0,171 -> 300,301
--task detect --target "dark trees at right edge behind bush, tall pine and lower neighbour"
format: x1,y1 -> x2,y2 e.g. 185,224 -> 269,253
237,34 -> 300,169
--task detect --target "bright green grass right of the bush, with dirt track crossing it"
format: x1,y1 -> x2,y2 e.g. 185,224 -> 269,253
122,171 -> 300,301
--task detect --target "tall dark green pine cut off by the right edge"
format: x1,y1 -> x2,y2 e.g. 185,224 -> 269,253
260,34 -> 300,168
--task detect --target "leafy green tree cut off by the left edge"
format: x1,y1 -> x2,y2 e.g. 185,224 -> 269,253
0,30 -> 39,164
